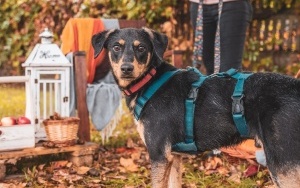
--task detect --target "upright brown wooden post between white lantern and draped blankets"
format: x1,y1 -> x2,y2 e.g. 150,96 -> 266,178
74,51 -> 90,141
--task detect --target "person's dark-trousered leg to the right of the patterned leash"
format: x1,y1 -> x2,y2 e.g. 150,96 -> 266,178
220,0 -> 252,72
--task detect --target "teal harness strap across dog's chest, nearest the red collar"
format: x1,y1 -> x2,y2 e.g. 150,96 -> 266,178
134,69 -> 180,120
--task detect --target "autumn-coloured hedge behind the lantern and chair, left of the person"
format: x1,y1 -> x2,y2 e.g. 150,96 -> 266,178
0,0 -> 176,76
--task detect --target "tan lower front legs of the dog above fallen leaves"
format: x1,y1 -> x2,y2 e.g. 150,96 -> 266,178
151,155 -> 182,188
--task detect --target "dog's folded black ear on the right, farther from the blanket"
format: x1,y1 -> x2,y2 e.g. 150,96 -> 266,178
143,27 -> 168,61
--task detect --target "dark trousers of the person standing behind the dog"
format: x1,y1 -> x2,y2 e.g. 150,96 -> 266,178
190,0 -> 252,74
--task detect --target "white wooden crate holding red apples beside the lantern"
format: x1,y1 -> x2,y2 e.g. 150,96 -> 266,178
0,124 -> 35,151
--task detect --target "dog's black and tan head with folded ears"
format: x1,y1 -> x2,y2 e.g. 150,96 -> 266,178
92,28 -> 168,88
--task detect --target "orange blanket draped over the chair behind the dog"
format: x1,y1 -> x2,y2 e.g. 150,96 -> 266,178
61,18 -> 106,83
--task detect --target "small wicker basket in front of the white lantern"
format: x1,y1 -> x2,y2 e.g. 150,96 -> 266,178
43,117 -> 79,144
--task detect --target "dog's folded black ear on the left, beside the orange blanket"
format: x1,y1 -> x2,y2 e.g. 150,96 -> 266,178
92,30 -> 114,58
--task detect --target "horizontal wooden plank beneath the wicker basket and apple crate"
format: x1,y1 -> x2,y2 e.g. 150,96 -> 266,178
0,142 -> 99,160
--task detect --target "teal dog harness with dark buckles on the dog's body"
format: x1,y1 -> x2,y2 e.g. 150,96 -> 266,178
134,68 -> 251,152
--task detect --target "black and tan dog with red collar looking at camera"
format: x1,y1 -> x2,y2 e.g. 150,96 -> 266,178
92,28 -> 300,188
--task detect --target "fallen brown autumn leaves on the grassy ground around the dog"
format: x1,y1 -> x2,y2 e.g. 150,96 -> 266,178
0,113 -> 273,188
